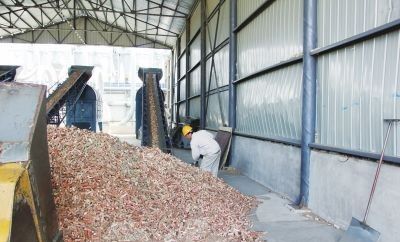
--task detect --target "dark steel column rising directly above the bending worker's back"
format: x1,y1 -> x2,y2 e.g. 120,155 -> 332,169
200,0 -> 207,129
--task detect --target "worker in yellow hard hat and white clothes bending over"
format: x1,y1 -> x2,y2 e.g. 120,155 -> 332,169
182,125 -> 221,176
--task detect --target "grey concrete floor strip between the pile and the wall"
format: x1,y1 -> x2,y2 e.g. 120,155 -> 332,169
173,149 -> 343,242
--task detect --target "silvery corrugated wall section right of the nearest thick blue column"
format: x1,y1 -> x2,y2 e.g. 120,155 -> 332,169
317,0 -> 400,156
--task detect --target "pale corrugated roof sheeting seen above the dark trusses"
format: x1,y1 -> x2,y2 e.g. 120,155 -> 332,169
0,0 -> 196,48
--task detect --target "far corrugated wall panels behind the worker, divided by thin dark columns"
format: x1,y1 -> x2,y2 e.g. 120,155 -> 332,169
172,0 -> 229,129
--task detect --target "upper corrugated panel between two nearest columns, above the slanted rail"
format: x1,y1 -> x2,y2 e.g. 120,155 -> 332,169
237,0 -> 303,78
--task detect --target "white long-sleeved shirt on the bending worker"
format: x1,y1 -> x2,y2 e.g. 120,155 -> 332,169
190,130 -> 220,160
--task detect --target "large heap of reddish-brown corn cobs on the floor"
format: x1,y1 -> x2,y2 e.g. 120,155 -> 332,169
48,126 -> 259,241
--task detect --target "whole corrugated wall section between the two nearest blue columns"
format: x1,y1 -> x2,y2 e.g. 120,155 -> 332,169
236,0 -> 303,140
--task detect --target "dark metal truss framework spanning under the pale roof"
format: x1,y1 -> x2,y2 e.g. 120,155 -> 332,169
0,0 -> 196,48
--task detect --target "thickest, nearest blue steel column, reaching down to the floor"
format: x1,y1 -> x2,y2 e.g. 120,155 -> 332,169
297,0 -> 317,206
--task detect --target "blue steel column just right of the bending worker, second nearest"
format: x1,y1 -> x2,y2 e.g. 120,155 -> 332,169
229,0 -> 237,129
